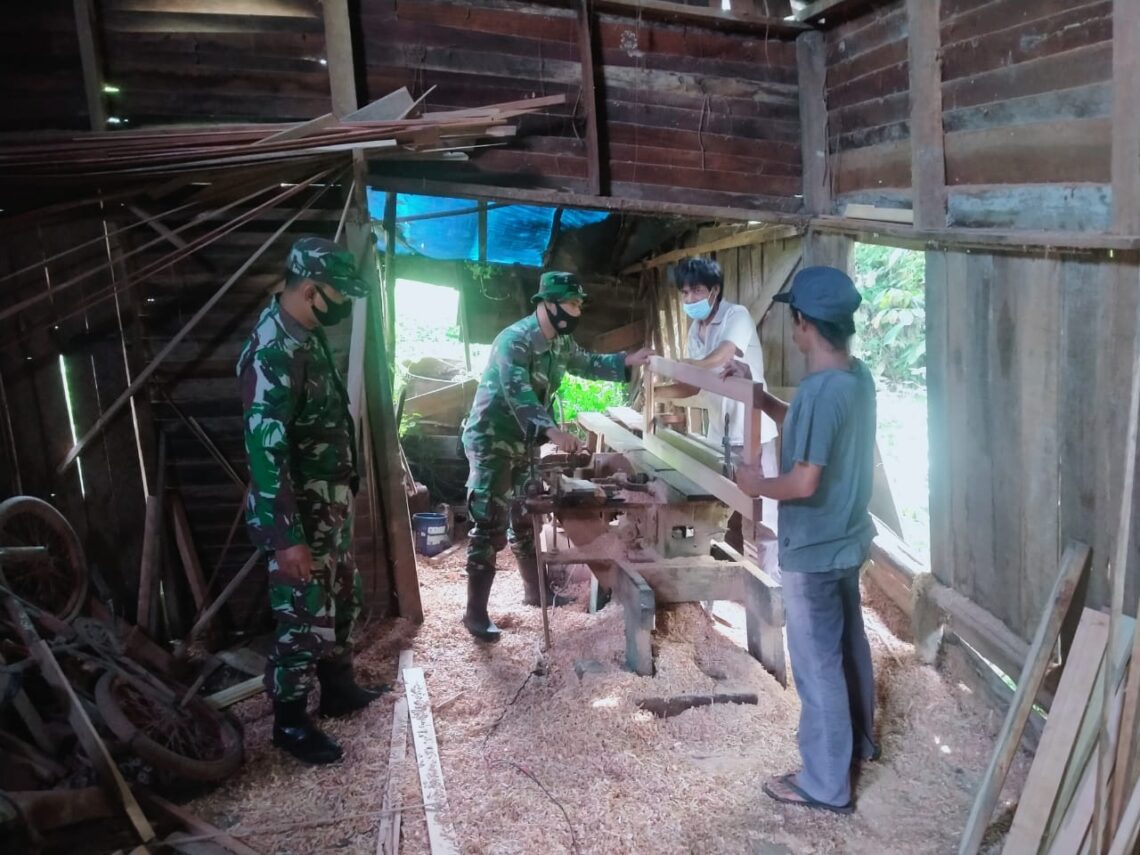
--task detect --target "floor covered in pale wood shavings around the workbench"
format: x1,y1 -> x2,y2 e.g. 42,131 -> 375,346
188,551 -> 1028,855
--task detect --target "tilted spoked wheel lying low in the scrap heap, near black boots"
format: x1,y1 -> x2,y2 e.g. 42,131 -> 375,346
95,671 -> 242,782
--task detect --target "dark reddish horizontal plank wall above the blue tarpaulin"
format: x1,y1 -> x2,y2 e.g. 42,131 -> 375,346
361,0 -> 801,211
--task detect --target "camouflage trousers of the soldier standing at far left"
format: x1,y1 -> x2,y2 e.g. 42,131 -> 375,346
266,482 -> 364,701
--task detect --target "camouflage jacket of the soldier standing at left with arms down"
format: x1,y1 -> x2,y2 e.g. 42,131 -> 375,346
237,300 -> 357,549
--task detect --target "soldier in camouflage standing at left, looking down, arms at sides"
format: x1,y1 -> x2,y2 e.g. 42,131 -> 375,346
237,237 -> 380,764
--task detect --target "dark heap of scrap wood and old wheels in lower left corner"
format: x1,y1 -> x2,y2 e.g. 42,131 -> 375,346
0,497 -> 271,854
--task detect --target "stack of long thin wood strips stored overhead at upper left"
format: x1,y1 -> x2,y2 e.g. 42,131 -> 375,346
0,89 -> 565,184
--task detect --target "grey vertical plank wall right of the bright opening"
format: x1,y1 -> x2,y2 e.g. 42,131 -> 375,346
927,252 -> 1140,638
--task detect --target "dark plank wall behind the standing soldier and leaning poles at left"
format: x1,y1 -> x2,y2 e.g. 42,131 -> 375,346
0,186 -> 392,627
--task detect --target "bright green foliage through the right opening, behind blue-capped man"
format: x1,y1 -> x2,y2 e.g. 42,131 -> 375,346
855,244 -> 926,388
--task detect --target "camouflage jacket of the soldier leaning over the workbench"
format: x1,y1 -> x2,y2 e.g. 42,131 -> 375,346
463,315 -> 626,457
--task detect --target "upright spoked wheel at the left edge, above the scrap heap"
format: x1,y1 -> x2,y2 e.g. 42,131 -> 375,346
0,496 -> 88,620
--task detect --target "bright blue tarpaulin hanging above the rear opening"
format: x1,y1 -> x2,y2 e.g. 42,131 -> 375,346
368,189 -> 609,267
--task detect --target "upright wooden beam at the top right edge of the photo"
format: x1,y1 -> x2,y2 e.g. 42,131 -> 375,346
1112,0 -> 1140,235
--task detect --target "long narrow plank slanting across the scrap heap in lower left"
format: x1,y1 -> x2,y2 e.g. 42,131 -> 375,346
3,596 -> 155,842
